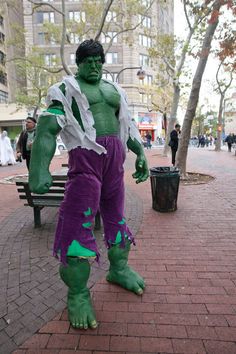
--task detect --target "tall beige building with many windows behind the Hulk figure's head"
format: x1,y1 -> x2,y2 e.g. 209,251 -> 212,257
7,0 -> 174,139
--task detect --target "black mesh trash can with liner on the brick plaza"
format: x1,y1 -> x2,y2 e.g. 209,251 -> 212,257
150,167 -> 180,213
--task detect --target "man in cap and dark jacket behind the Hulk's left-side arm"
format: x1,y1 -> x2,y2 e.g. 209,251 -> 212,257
16,117 -> 36,170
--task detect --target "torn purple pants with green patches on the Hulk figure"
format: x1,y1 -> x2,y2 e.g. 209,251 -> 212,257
54,136 -> 134,264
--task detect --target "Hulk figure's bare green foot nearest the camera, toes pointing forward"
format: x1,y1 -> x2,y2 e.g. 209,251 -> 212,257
67,289 -> 97,329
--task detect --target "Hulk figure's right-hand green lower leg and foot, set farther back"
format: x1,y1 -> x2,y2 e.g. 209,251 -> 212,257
106,241 -> 145,295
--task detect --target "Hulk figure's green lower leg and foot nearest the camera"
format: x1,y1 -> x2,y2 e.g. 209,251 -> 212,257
60,257 -> 97,329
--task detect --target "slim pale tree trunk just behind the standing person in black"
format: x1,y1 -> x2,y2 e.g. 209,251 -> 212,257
163,84 -> 180,156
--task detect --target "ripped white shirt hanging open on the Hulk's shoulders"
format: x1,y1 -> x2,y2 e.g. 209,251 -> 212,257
43,76 -> 141,154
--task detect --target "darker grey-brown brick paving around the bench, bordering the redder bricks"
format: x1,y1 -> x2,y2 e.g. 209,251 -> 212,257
0,151 -> 142,354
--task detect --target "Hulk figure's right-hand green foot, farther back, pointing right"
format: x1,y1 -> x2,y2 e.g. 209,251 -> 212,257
106,265 -> 145,295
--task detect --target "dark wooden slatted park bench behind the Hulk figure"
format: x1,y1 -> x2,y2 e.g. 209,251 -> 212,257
16,174 -> 101,230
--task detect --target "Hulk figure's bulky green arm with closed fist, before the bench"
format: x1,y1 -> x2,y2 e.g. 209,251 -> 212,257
29,114 -> 61,194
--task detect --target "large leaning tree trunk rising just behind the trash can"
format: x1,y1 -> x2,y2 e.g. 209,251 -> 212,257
176,0 -> 223,177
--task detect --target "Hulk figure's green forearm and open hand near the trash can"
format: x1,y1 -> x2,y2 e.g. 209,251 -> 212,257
127,138 -> 149,183
